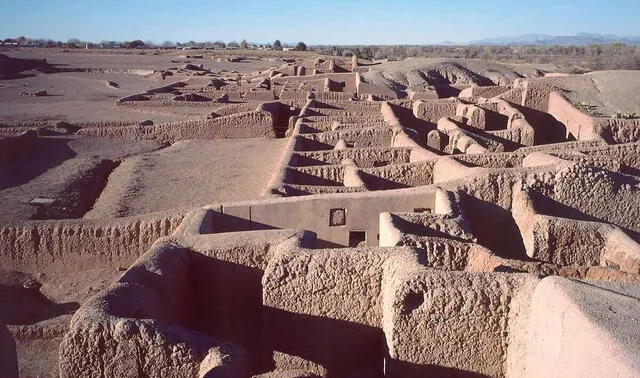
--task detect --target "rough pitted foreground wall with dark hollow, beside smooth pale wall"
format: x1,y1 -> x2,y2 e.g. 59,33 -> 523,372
382,257 -> 537,378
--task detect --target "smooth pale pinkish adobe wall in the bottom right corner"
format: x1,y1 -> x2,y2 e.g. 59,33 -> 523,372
521,277 -> 640,377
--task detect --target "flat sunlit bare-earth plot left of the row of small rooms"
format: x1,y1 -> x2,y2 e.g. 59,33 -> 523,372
85,138 -> 285,218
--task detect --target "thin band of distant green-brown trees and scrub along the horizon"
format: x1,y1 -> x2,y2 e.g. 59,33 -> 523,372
2,37 -> 640,72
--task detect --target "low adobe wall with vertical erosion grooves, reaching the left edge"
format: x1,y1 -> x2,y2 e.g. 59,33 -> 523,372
0,213 -> 184,273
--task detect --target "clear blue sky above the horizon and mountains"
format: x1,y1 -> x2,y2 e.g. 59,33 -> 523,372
0,0 -> 640,44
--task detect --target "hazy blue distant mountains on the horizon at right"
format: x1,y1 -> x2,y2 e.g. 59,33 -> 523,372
458,33 -> 640,45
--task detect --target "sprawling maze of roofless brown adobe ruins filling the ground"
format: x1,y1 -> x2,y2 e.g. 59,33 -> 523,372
0,51 -> 640,378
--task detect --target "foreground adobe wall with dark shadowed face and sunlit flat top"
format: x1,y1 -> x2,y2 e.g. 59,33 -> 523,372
178,230 -> 315,369
